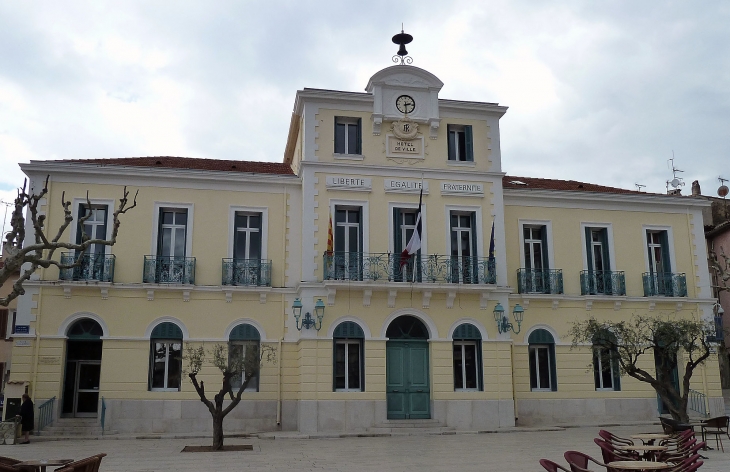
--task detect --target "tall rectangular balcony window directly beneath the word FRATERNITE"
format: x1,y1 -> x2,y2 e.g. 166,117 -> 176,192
449,211 -> 478,284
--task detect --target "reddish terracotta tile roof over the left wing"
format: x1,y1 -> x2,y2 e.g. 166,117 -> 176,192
61,156 -> 294,175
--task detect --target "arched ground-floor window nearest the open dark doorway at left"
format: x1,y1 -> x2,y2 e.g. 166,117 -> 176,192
149,322 -> 182,392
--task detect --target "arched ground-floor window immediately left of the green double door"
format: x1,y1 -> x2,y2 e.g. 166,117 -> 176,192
332,321 -> 365,392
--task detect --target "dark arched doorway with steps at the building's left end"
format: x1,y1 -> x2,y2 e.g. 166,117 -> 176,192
61,318 -> 104,418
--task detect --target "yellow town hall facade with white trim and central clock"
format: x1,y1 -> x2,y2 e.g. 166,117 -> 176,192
11,65 -> 723,432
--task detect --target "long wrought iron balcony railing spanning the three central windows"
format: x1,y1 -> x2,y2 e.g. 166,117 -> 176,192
324,252 -> 497,284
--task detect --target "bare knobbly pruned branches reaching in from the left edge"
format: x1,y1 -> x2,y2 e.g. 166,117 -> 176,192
0,176 -> 139,306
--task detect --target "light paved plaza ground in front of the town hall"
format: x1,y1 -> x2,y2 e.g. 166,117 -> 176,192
5,425 -> 730,472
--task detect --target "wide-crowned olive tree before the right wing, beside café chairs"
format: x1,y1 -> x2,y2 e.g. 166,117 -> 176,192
570,315 -> 715,422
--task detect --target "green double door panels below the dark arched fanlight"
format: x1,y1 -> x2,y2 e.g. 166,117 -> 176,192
385,341 -> 431,420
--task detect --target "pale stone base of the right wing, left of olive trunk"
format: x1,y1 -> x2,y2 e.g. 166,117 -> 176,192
517,398 -> 659,426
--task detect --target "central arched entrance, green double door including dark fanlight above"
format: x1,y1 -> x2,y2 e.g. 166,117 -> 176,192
385,315 -> 431,420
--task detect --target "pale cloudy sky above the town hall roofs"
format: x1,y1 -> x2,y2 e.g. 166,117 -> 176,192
0,0 -> 730,222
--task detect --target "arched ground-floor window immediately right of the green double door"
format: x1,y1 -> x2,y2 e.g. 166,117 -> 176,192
453,323 -> 484,392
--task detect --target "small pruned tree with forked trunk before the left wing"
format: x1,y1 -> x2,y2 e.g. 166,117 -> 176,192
183,344 -> 276,451
